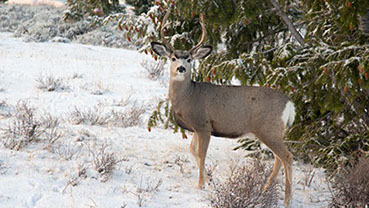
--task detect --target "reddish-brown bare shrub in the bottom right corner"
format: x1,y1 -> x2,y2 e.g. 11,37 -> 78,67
331,157 -> 369,208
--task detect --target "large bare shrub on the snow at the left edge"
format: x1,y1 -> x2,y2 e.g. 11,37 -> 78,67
1,101 -> 42,150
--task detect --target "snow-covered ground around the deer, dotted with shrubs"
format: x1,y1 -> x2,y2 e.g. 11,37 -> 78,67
0,33 -> 329,208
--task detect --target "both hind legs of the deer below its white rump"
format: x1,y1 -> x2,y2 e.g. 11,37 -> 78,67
259,133 -> 293,207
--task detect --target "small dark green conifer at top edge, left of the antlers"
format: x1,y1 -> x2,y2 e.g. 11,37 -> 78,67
63,0 -> 124,22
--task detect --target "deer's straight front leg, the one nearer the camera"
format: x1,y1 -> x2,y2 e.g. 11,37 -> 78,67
195,132 -> 210,189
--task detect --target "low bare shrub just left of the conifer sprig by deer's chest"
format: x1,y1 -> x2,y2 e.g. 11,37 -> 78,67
109,106 -> 145,128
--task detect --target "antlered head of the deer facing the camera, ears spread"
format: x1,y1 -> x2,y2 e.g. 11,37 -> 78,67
151,10 -> 213,81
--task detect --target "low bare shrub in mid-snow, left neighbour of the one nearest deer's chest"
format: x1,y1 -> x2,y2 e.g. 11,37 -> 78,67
70,106 -> 108,125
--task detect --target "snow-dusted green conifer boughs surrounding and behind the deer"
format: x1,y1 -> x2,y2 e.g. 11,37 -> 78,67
104,0 -> 369,170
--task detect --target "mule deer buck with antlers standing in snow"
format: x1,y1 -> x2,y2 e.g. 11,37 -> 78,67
151,11 -> 295,206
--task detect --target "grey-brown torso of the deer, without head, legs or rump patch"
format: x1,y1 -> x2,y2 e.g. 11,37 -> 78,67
169,81 -> 289,138
